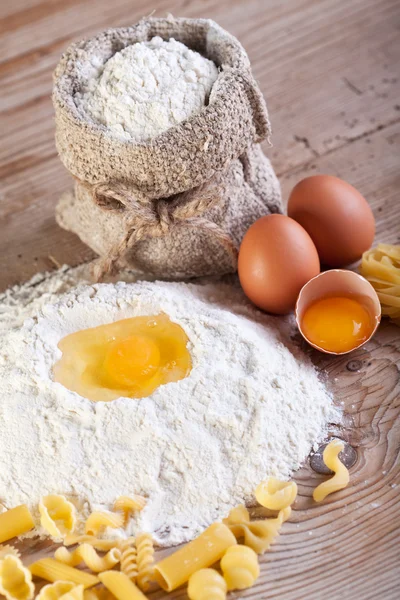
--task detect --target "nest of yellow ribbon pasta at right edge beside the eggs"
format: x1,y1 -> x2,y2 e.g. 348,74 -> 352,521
360,244 -> 400,325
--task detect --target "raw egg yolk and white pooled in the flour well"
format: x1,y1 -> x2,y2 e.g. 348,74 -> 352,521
53,314 -> 192,402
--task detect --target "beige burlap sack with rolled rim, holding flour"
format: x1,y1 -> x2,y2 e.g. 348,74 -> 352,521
53,17 -> 281,278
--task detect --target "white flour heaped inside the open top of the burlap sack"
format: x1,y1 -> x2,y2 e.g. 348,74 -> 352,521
75,37 -> 218,142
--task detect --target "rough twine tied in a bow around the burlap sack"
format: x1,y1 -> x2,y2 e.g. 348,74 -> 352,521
85,181 -> 237,281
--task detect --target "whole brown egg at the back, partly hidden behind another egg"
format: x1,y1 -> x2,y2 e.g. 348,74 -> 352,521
287,175 -> 375,267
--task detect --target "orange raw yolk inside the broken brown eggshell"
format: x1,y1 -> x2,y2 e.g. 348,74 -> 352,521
301,297 -> 373,353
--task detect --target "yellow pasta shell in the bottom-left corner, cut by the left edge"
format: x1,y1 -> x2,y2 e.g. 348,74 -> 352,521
0,554 -> 35,600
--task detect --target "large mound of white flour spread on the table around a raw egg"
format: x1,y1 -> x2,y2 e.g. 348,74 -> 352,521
0,267 -> 338,545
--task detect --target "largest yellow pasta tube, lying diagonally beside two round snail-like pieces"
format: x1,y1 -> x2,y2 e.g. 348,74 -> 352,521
155,523 -> 236,592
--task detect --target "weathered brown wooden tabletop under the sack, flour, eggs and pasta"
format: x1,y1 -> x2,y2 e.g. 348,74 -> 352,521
0,0 -> 400,600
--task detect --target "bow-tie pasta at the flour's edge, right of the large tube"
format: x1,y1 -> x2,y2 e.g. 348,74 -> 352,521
223,506 -> 291,554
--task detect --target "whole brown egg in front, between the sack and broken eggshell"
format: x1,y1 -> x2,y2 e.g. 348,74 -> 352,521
238,215 -> 320,314
